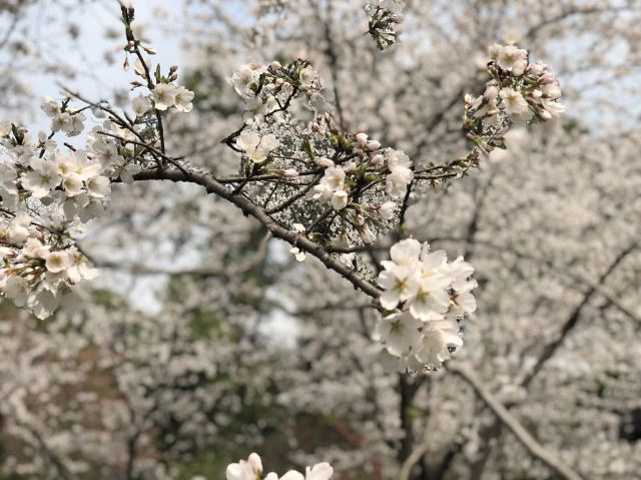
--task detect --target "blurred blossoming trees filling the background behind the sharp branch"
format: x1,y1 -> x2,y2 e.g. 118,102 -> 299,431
0,0 -> 641,480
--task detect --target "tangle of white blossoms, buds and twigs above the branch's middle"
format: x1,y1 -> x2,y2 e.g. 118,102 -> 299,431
227,60 -> 414,251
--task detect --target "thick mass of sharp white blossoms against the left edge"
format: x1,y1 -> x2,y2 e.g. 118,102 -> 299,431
0,117 -> 111,318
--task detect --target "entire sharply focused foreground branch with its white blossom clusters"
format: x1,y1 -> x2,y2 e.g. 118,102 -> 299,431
0,1 -> 563,374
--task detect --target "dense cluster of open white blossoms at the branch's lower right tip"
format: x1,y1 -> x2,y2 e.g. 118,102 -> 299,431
376,238 -> 477,372
